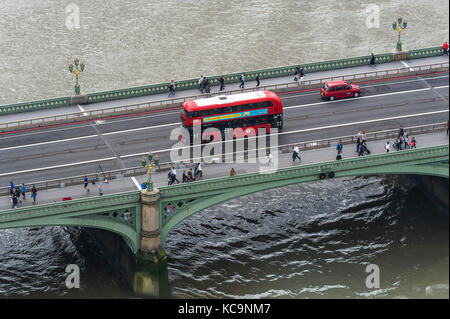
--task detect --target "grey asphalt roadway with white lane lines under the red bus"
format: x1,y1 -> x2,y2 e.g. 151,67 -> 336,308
0,72 -> 449,187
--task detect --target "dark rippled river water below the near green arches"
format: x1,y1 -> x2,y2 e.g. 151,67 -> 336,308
0,177 -> 449,298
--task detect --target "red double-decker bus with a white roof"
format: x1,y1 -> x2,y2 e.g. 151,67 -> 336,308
181,91 -> 283,142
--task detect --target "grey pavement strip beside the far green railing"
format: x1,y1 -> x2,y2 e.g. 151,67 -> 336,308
0,55 -> 449,122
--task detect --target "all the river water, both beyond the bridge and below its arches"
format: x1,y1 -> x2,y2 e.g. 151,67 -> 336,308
0,0 -> 449,298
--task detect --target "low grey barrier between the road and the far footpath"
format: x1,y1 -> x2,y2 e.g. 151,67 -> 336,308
1,66 -> 449,132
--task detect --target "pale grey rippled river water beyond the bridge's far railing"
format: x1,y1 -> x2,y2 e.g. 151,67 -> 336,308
0,0 -> 449,104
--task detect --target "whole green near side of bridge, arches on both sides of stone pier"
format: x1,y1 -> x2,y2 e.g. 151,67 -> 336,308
0,144 -> 449,253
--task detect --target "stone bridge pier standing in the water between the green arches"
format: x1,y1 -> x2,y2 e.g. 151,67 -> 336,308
132,188 -> 169,298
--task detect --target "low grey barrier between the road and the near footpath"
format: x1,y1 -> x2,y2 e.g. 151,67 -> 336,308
0,123 -> 447,196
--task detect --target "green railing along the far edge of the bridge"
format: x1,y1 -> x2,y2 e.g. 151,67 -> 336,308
0,47 -> 443,115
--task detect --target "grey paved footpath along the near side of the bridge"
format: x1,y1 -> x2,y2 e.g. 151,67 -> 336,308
0,131 -> 449,210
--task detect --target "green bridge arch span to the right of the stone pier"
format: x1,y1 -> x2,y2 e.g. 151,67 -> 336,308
159,145 -> 449,247
